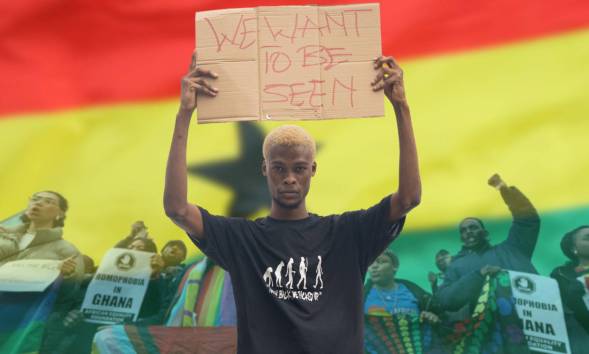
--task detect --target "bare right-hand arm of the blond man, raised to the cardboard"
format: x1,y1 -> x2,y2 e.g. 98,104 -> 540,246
372,57 -> 421,221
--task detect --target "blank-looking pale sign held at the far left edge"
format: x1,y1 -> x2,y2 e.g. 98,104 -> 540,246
0,259 -> 62,292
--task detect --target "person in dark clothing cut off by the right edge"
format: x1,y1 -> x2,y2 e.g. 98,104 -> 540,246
550,225 -> 589,334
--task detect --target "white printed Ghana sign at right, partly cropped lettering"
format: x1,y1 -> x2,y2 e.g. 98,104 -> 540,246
509,271 -> 571,354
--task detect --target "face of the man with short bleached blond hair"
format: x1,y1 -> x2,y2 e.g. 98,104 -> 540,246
262,146 -> 317,209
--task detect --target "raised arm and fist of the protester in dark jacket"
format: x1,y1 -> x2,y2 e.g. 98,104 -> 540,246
489,174 -> 540,258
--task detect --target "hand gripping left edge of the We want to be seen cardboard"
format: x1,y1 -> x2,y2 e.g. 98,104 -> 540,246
180,51 -> 219,112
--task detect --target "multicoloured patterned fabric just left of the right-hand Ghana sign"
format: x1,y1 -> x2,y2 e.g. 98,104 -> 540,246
445,272 -> 529,354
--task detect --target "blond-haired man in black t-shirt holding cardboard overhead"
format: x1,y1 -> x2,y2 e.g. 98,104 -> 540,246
164,53 -> 421,354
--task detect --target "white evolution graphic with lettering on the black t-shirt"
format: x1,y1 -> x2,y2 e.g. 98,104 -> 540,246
262,256 -> 323,301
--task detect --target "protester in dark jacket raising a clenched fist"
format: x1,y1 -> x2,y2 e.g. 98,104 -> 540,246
435,174 -> 540,310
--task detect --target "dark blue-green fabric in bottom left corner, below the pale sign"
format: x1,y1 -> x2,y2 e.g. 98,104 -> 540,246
0,277 -> 61,354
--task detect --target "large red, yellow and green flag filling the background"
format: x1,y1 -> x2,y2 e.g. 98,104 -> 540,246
0,0 -> 589,286
